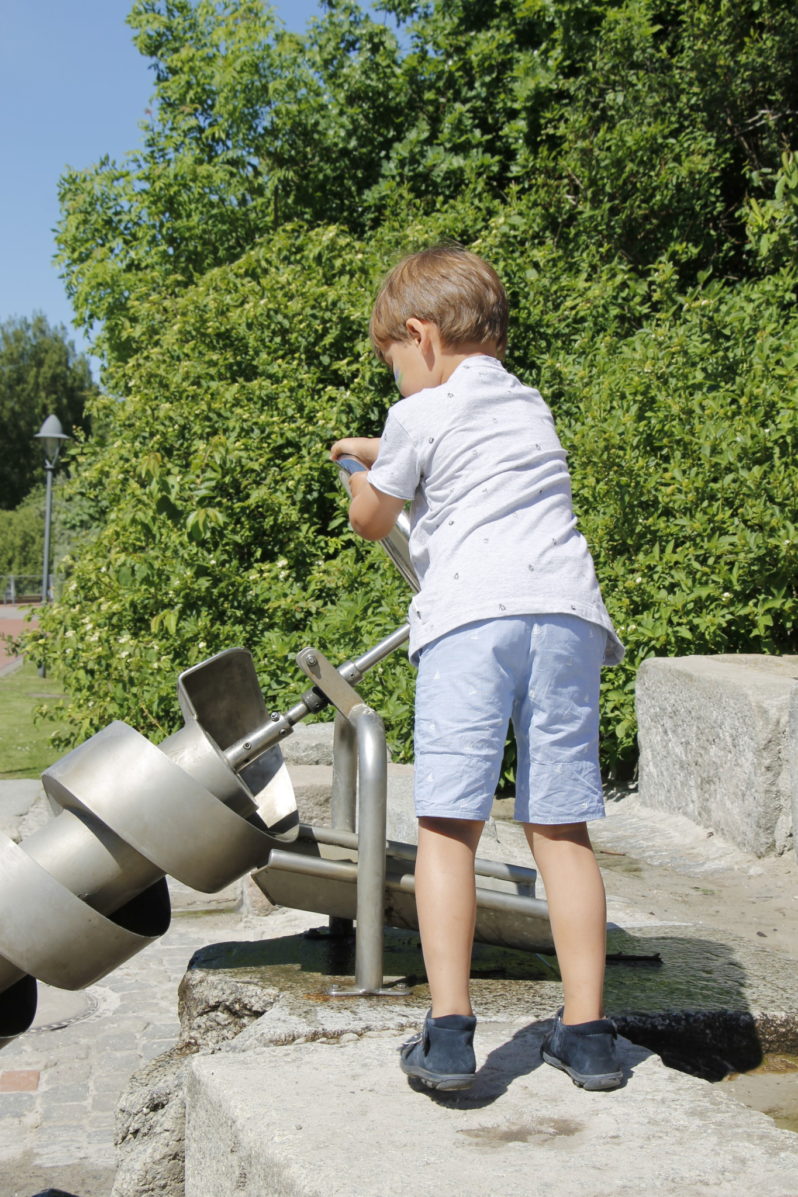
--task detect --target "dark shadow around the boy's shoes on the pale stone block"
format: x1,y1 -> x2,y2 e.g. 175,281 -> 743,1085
408,1019 -> 651,1110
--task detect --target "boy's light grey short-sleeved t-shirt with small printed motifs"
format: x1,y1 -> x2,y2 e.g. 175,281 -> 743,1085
368,354 -> 623,664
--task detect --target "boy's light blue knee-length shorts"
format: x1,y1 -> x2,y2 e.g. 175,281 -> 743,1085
415,615 -> 607,825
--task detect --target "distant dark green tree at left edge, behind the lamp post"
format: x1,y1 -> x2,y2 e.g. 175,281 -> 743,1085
0,312 -> 97,509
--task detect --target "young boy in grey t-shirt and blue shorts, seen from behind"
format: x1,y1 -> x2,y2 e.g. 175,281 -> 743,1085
331,247 -> 623,1089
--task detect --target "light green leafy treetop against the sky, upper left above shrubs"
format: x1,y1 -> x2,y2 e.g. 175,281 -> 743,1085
57,0 -> 403,360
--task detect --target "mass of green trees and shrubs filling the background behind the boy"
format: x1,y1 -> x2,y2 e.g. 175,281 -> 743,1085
35,0 -> 798,772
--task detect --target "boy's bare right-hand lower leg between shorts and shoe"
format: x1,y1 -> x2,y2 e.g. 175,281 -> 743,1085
524,822 -> 607,1025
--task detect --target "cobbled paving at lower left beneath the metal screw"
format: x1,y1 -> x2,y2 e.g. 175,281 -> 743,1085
0,890 -> 257,1197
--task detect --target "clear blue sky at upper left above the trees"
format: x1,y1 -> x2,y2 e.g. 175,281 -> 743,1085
0,0 -> 378,363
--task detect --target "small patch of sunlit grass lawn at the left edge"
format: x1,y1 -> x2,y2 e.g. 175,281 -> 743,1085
0,661 -> 70,778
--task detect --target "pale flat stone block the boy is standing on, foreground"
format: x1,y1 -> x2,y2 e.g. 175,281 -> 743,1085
185,1021 -> 798,1197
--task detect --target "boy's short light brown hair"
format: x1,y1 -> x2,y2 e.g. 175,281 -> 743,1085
368,245 -> 507,359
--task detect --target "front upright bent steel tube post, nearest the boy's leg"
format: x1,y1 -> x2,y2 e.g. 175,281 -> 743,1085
349,704 -> 388,994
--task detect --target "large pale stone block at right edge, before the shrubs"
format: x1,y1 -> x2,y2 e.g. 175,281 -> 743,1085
636,655 -> 798,857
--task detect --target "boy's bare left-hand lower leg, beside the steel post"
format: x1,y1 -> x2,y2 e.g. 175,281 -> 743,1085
415,818 -> 485,1019
